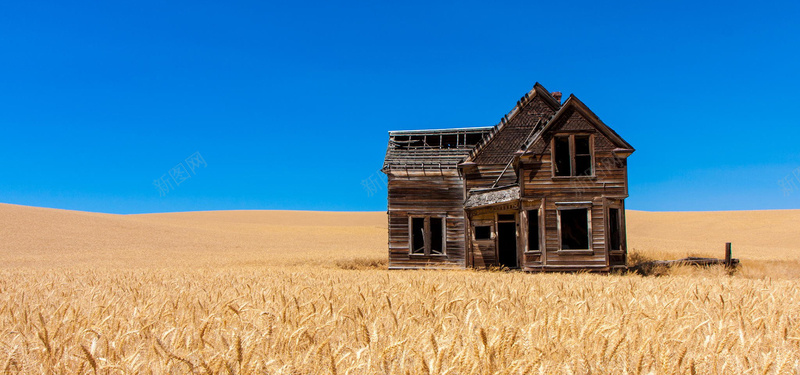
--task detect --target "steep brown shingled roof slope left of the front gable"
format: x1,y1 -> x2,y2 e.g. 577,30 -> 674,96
467,82 -> 561,164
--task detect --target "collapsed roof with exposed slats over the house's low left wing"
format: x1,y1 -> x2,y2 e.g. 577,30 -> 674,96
383,126 -> 492,172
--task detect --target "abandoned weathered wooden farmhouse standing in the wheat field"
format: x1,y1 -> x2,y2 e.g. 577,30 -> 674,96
382,83 -> 634,271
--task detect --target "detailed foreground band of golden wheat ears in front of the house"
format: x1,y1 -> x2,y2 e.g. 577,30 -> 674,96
0,267 -> 800,374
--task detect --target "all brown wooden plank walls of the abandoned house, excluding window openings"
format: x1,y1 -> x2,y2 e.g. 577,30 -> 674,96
387,99 -> 628,271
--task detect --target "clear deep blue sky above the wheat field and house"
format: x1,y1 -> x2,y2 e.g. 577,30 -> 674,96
0,0 -> 800,213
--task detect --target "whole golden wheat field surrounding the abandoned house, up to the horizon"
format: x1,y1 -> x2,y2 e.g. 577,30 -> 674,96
0,204 -> 800,374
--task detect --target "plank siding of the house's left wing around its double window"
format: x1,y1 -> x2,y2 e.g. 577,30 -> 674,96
387,169 -> 465,269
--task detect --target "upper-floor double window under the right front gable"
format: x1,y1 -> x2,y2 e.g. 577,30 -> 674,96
553,134 -> 594,177
